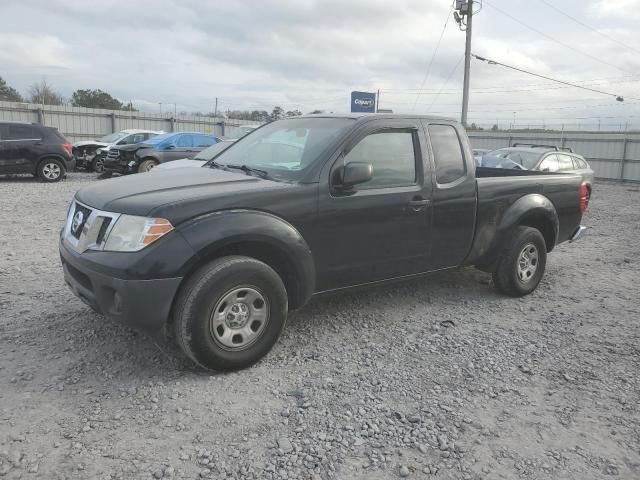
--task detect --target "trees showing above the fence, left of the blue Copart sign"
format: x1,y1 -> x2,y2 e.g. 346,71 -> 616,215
0,77 -> 323,122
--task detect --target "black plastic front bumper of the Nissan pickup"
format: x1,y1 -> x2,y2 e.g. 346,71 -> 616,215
59,237 -> 182,335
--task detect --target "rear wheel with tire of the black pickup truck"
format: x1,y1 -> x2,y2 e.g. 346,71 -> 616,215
493,227 -> 547,297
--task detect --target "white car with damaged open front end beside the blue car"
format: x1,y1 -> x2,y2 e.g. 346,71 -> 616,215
72,129 -> 164,172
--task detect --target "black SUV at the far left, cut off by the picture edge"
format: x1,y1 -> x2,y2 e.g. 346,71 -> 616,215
0,122 -> 76,182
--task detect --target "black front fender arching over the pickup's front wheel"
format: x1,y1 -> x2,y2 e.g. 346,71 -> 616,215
177,209 -> 316,304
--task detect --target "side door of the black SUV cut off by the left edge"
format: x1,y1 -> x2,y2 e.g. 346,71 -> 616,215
0,124 -> 42,173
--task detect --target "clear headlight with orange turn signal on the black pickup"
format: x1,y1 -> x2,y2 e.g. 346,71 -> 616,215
104,215 -> 173,252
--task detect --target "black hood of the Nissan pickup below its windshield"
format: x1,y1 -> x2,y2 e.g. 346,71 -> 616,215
76,168 -> 293,221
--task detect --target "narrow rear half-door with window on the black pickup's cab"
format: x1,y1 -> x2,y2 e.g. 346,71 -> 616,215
425,122 -> 477,270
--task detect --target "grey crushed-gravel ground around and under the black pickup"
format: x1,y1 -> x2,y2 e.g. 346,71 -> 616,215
0,174 -> 640,480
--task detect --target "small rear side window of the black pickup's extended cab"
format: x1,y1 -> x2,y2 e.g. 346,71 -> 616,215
427,124 -> 467,185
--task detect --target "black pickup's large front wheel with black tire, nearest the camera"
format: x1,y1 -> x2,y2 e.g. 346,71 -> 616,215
173,256 -> 288,371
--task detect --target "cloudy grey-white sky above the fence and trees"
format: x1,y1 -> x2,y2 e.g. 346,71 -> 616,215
0,0 -> 640,128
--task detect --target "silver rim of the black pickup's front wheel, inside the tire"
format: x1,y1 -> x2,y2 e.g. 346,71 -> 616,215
209,286 -> 269,350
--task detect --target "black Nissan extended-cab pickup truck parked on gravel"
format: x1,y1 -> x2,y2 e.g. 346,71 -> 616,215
59,115 -> 586,370
